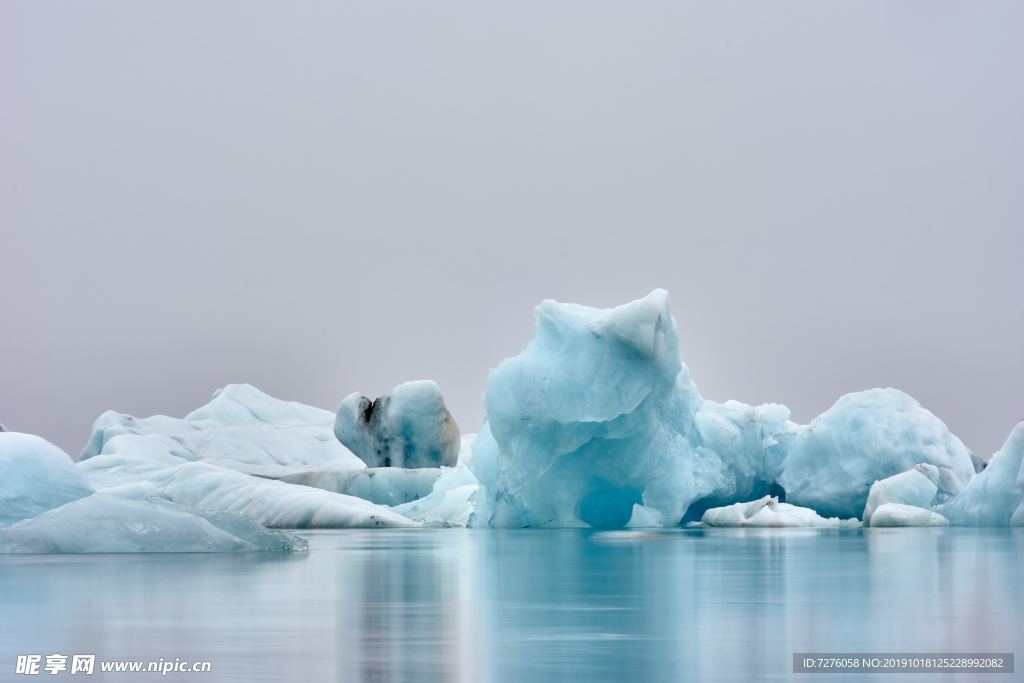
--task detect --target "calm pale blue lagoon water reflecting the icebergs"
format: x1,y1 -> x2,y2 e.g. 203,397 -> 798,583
0,528 -> 1024,683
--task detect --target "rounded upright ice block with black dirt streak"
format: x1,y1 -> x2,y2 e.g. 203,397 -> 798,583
334,380 -> 460,468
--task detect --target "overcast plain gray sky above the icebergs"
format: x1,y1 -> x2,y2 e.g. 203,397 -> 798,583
0,0 -> 1024,456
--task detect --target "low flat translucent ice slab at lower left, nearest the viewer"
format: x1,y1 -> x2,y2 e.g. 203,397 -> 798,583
0,493 -> 306,553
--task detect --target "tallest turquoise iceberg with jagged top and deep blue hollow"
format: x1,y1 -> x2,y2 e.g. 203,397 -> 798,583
468,290 -> 796,527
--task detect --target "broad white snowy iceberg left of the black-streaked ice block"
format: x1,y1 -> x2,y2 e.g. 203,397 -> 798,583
78,384 -> 417,528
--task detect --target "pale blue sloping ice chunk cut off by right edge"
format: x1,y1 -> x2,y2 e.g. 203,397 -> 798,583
938,421 -> 1024,526
